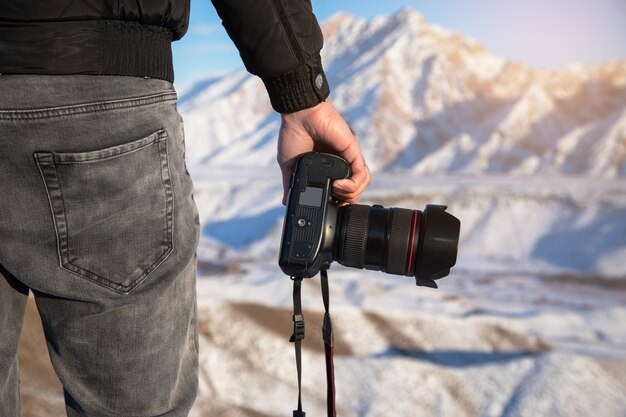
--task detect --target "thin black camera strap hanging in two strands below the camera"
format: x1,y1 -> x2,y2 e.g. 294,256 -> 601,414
289,269 -> 337,417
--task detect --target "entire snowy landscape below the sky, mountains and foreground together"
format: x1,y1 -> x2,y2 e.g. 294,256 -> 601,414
15,9 -> 626,417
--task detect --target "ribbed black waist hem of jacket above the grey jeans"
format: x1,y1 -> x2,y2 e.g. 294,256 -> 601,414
0,20 -> 174,82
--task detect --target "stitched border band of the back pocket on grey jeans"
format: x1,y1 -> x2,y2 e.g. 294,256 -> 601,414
33,130 -> 174,294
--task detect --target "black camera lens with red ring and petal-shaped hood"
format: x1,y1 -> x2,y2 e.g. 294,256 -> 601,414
333,204 -> 460,287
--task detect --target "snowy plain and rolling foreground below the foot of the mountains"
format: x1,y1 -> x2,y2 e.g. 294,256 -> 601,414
176,167 -> 626,417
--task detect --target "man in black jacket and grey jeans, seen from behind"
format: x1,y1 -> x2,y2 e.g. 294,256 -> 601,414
0,0 -> 370,417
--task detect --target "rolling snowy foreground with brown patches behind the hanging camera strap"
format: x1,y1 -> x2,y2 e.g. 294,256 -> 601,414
188,262 -> 626,417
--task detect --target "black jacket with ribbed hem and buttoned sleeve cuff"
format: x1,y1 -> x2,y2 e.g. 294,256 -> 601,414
0,0 -> 329,113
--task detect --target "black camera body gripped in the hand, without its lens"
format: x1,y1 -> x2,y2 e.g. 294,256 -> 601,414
278,152 -> 350,278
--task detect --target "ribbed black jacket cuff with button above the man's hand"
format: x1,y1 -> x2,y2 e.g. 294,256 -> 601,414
261,65 -> 330,113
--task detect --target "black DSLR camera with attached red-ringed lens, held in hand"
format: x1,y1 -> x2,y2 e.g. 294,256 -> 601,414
278,152 -> 460,288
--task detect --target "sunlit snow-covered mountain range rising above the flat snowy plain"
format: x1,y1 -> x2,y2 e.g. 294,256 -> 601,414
180,9 -> 626,178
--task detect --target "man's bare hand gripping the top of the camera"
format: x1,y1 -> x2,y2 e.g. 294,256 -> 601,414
277,100 -> 372,205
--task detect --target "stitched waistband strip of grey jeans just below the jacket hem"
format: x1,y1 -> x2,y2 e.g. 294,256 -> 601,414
0,92 -> 177,120
